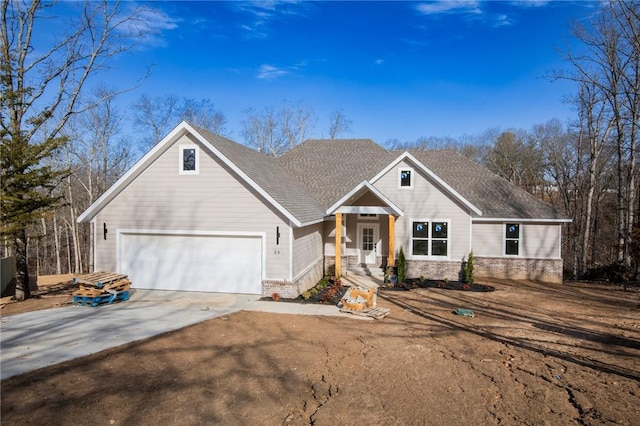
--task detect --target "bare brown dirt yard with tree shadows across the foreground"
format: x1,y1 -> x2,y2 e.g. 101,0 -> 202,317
0,281 -> 640,425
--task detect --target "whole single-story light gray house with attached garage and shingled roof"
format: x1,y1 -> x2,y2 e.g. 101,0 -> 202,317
78,122 -> 569,297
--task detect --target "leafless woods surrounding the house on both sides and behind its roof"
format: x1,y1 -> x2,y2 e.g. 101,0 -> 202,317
0,0 -> 640,297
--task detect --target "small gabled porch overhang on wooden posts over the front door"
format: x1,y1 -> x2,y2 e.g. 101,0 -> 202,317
327,181 -> 404,277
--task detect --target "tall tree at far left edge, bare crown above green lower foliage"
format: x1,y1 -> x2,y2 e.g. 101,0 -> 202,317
0,0 -> 154,300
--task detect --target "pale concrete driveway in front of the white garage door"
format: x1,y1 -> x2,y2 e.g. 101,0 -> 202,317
0,290 -> 259,380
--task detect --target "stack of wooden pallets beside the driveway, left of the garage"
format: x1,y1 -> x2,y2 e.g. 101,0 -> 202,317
73,272 -> 131,306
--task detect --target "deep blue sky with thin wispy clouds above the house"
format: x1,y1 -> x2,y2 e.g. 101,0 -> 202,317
53,1 -> 597,143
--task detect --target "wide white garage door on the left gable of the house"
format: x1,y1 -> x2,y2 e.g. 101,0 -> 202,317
118,234 -> 262,294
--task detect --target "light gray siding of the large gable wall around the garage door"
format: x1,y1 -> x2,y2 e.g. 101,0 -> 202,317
95,136 -> 290,279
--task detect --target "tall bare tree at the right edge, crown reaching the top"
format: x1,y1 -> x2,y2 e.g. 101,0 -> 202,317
556,0 -> 640,270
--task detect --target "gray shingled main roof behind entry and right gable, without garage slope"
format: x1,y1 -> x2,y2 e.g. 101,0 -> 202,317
275,139 -> 566,220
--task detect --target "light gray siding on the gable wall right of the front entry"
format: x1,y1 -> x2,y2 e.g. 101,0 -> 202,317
375,162 -> 471,260
